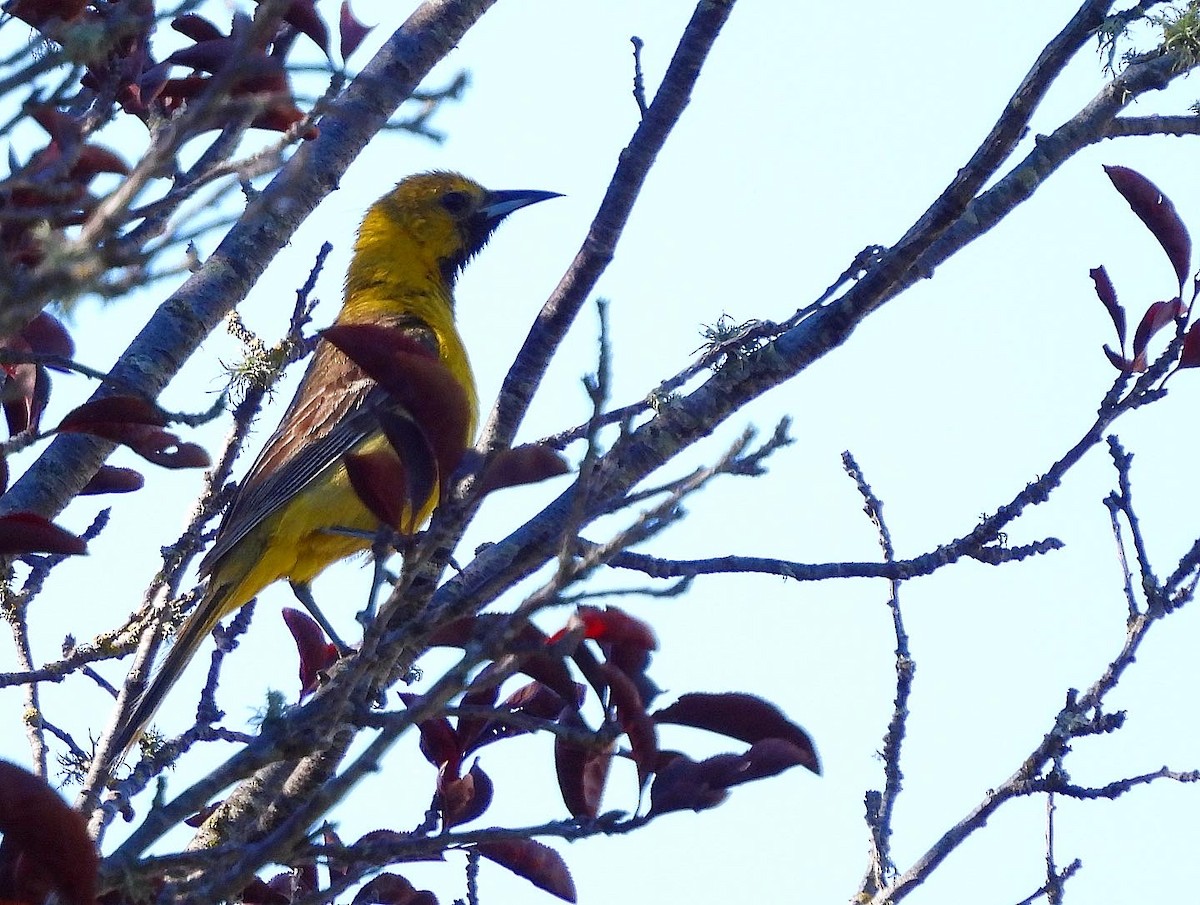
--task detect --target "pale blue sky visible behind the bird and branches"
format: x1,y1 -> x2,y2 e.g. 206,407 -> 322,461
0,0 -> 1200,905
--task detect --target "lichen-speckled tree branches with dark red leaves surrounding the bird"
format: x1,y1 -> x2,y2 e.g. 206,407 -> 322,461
7,0 -> 1200,903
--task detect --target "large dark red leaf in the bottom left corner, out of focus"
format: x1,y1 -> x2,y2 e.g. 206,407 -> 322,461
0,761 -> 100,905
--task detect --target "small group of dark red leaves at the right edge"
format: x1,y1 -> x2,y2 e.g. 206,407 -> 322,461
1090,167 -> 1200,373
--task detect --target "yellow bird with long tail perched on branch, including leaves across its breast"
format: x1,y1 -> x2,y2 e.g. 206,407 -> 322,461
107,173 -> 558,763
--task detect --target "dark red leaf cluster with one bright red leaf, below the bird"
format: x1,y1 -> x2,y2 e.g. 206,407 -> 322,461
417,606 -> 820,826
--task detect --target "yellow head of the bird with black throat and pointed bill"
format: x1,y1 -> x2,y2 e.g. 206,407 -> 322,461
359,172 -> 559,288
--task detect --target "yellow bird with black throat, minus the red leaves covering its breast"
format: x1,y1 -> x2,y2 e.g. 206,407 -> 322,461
108,173 -> 559,762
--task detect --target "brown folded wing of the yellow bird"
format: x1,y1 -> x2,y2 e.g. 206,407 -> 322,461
199,320 -> 437,576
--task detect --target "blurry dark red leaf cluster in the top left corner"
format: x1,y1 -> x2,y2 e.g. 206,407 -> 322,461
0,0 -> 371,274
